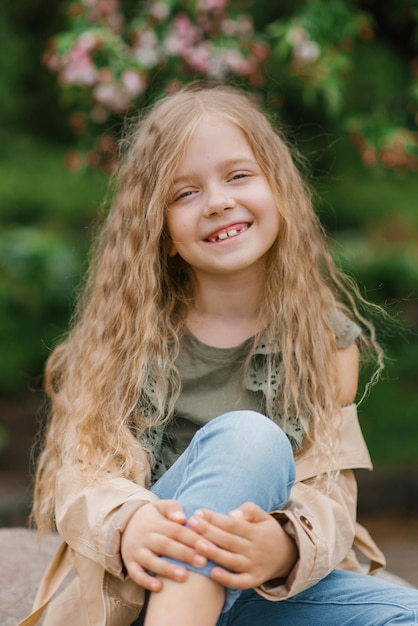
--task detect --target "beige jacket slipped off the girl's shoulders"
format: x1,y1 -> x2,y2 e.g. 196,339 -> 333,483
19,404 -> 385,626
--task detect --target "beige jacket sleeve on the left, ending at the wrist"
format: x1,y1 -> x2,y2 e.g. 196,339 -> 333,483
55,460 -> 157,580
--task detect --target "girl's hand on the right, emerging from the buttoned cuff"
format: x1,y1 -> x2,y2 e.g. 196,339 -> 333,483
188,502 -> 298,589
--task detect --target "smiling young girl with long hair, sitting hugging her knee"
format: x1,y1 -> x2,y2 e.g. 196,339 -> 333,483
24,85 -> 418,626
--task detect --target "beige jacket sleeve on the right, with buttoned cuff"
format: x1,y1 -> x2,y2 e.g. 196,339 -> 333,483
257,405 -> 378,600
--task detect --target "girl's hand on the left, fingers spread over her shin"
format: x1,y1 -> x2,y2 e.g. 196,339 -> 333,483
121,500 -> 206,591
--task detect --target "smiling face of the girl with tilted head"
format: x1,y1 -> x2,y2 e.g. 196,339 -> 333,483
167,117 -> 280,278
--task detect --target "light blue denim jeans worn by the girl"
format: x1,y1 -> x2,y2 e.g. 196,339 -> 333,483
133,411 -> 418,626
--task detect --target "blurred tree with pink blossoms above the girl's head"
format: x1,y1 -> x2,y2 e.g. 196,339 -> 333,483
38,0 -> 418,170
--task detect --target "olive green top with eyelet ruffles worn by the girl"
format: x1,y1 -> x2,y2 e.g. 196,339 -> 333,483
140,314 -> 361,481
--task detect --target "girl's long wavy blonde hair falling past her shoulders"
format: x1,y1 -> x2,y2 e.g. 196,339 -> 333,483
33,85 -> 382,530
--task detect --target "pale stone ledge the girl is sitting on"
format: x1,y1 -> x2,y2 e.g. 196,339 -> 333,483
0,528 -> 412,626
